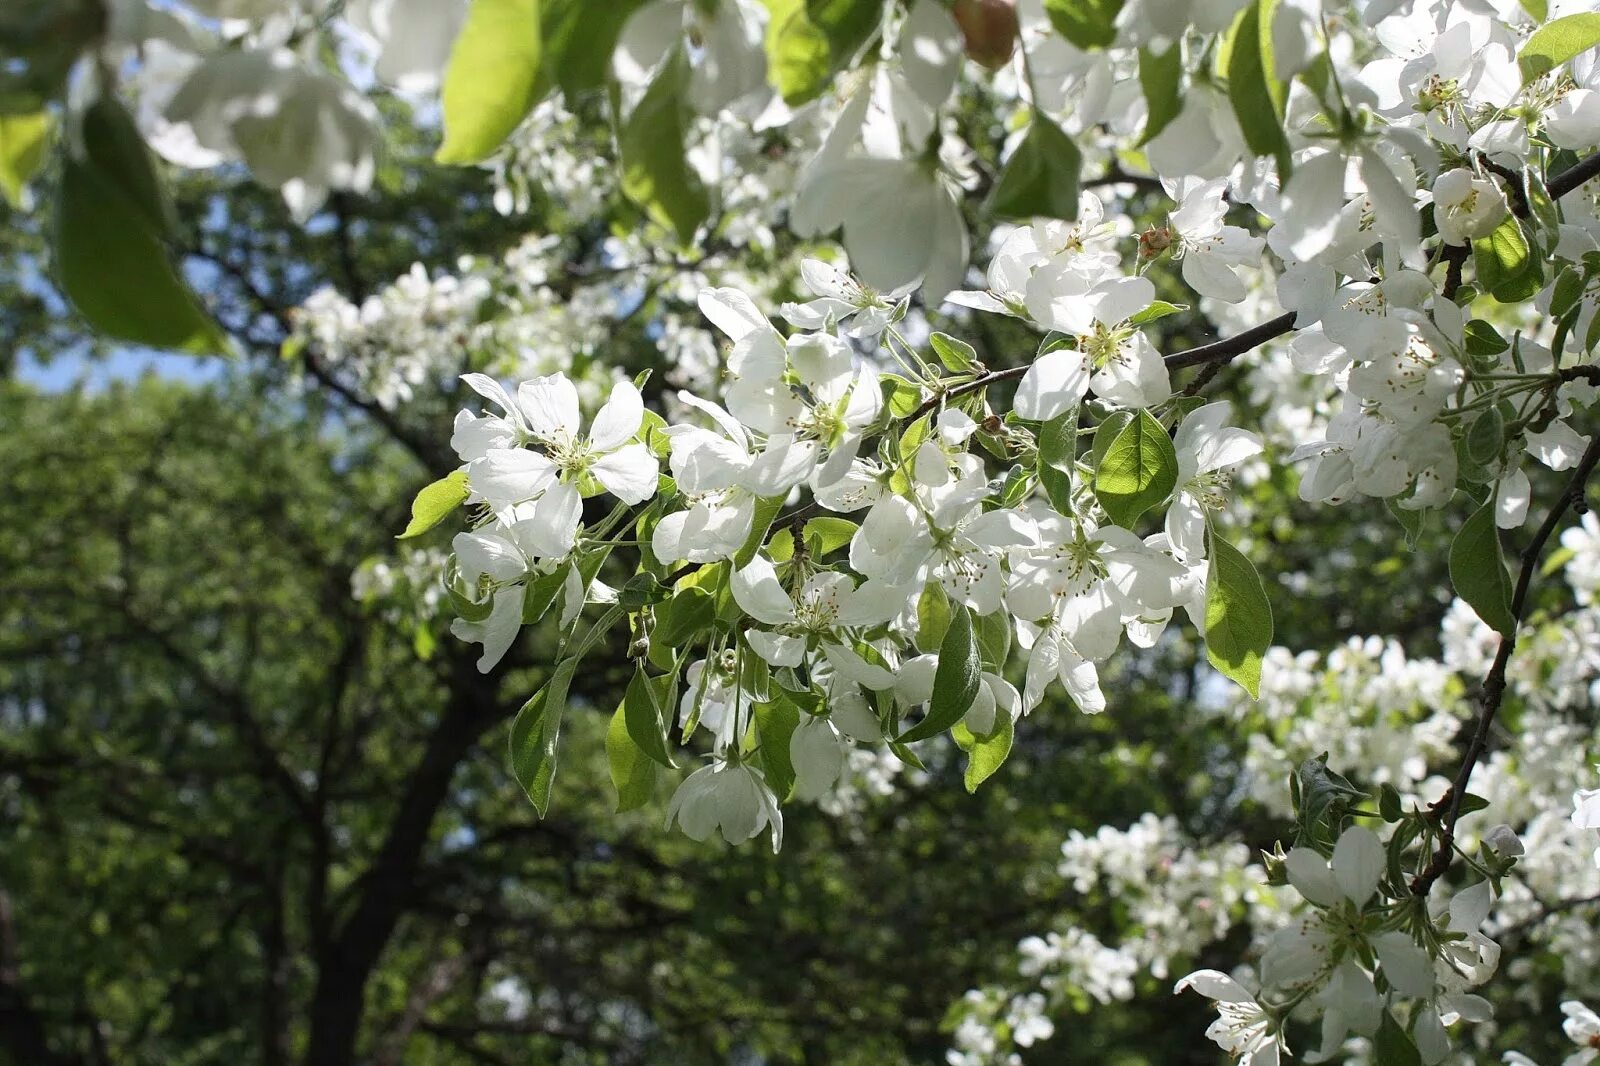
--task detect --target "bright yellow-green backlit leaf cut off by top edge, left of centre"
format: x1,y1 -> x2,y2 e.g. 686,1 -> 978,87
434,0 -> 544,163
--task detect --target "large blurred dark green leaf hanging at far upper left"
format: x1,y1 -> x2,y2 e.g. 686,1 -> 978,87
54,99 -> 227,354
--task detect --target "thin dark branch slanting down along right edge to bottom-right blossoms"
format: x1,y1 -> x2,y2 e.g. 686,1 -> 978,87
1411,434 -> 1600,896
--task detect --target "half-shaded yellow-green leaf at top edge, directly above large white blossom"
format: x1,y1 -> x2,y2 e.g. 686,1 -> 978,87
766,0 -> 883,106
